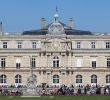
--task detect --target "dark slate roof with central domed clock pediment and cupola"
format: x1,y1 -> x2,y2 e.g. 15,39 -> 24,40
22,13 -> 92,35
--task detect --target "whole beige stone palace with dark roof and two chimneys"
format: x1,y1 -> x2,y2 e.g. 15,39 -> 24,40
0,13 -> 110,86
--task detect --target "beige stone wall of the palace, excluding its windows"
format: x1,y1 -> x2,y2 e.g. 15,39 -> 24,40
0,36 -> 110,85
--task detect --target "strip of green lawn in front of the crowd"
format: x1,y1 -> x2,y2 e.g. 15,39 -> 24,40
0,96 -> 110,100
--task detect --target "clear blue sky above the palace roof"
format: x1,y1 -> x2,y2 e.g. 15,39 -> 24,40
0,0 -> 110,32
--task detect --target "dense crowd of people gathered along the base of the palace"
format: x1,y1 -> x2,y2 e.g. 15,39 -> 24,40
0,85 -> 110,95
